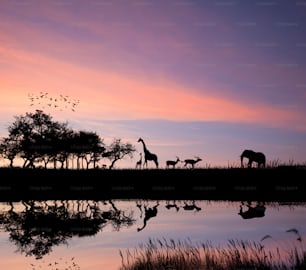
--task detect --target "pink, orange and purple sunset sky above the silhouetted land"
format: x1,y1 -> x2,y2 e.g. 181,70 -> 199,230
0,0 -> 306,167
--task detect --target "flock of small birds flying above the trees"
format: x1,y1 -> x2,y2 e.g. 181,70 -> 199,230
28,91 -> 80,112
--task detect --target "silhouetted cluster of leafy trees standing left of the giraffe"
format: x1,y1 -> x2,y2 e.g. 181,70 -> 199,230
0,110 -> 136,169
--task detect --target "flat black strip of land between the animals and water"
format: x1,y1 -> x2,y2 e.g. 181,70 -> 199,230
0,166 -> 306,202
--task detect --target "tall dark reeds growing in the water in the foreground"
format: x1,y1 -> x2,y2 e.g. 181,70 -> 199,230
120,239 -> 306,270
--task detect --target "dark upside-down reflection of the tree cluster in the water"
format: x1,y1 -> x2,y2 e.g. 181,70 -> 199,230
0,201 -> 134,259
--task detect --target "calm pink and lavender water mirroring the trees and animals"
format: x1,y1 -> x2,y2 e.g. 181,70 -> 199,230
0,200 -> 306,270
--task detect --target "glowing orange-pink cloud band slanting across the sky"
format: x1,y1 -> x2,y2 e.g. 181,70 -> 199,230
1,40 -> 305,132
